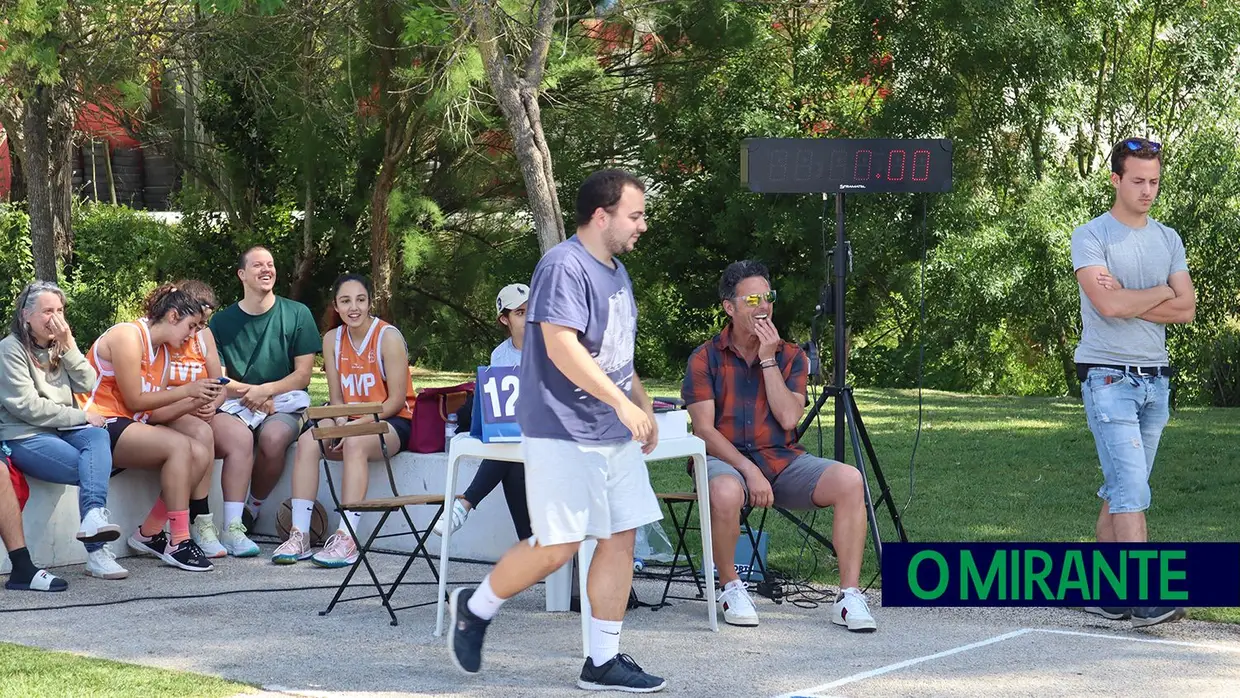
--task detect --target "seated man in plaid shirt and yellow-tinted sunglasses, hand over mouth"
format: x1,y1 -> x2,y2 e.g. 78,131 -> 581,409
681,260 -> 877,632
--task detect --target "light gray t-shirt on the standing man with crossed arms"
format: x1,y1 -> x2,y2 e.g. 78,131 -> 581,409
1073,212 -> 1188,366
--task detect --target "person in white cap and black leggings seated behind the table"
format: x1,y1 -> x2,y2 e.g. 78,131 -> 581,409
435,284 -> 533,541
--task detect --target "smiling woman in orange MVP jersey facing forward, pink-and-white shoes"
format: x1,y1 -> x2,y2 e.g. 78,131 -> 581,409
272,274 -> 414,567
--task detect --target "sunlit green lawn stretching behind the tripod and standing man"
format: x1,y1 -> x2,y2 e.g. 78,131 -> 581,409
311,372 -> 1240,624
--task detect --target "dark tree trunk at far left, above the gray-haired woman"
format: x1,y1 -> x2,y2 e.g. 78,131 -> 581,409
22,86 -> 57,281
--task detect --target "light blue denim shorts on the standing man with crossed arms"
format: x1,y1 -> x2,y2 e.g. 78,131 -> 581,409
1081,368 -> 1171,513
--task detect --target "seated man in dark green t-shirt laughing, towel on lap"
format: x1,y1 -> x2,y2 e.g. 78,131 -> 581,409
211,247 -> 322,557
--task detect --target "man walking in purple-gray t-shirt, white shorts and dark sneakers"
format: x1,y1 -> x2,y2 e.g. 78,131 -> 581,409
448,170 -> 666,693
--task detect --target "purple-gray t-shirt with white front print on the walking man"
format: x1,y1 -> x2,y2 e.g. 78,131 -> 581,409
517,236 -> 637,444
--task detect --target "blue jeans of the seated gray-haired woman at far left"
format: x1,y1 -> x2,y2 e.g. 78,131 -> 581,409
4,426 -> 112,553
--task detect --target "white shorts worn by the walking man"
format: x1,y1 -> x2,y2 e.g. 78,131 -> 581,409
522,436 -> 663,546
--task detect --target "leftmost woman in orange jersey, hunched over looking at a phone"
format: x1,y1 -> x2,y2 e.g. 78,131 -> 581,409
81,284 -> 223,572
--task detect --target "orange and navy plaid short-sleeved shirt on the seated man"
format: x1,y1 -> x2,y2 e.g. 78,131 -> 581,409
681,324 -> 810,479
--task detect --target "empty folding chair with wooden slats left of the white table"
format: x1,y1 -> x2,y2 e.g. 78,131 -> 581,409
306,403 -> 444,625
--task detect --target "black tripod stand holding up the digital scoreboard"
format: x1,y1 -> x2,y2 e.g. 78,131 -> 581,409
776,193 -> 909,568
